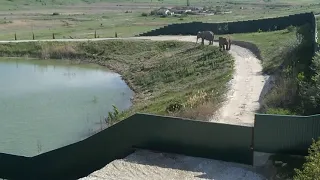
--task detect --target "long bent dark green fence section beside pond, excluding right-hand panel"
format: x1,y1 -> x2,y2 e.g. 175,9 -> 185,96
0,114 -> 253,180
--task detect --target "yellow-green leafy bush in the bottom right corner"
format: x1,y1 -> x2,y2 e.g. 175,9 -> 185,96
293,138 -> 320,180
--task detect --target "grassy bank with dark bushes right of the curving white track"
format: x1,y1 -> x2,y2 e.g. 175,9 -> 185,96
233,25 -> 319,115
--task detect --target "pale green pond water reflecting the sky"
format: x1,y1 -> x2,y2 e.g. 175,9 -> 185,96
0,58 -> 133,156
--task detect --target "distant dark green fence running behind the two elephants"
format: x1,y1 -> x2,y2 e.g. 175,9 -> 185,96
138,13 -> 314,36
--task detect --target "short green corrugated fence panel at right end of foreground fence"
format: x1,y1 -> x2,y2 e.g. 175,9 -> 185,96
254,114 -> 320,155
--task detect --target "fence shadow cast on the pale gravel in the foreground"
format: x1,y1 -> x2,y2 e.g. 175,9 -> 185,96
123,150 -> 264,180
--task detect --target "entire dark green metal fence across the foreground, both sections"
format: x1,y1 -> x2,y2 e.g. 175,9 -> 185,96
0,114 -> 320,180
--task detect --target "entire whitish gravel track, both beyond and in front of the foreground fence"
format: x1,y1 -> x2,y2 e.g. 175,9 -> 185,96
0,36 -> 265,180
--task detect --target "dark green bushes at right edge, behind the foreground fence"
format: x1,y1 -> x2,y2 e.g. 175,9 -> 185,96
261,24 -> 320,115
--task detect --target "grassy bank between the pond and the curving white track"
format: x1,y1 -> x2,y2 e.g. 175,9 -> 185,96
0,40 -> 233,119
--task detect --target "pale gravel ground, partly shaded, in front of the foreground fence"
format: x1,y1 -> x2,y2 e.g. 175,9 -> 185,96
80,150 -> 265,180
